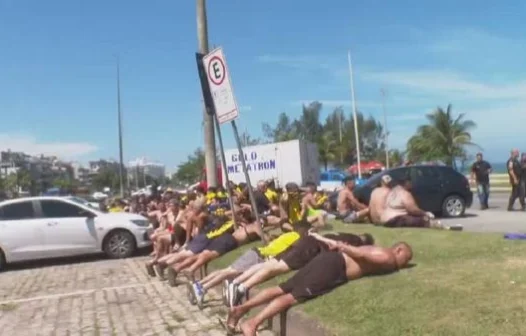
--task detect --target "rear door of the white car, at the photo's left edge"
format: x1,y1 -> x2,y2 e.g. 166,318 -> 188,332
0,200 -> 46,262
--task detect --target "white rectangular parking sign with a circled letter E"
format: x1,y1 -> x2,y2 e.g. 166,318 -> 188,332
203,48 -> 239,124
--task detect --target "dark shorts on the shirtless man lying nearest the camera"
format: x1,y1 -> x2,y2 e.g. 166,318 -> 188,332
279,251 -> 348,303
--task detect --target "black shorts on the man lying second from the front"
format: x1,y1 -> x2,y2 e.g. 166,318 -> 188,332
276,236 -> 322,271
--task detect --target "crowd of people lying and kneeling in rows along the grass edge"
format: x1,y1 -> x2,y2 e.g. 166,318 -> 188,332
146,178 -> 412,335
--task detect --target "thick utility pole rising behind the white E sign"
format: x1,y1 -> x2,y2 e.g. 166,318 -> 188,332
196,0 -> 217,187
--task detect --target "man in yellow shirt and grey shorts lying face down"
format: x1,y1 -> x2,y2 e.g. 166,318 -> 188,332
187,221 -> 311,306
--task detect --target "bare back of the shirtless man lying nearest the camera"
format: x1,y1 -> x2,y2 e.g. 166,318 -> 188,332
342,245 -> 398,280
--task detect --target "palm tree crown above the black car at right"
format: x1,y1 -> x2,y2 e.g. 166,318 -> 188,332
407,104 -> 478,167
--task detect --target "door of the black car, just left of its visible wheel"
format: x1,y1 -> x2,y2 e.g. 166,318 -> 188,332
410,166 -> 443,212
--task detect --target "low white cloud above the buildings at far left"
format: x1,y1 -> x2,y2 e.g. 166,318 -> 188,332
0,133 -> 98,159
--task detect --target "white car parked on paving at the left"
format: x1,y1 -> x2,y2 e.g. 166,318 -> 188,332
0,196 -> 151,270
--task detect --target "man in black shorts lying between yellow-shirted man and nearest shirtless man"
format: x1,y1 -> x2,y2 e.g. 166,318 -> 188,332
226,232 -> 374,307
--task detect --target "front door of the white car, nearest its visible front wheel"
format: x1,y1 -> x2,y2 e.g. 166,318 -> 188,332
39,199 -> 98,257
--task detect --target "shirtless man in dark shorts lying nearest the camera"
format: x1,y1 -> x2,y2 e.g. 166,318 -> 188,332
226,242 -> 413,336
